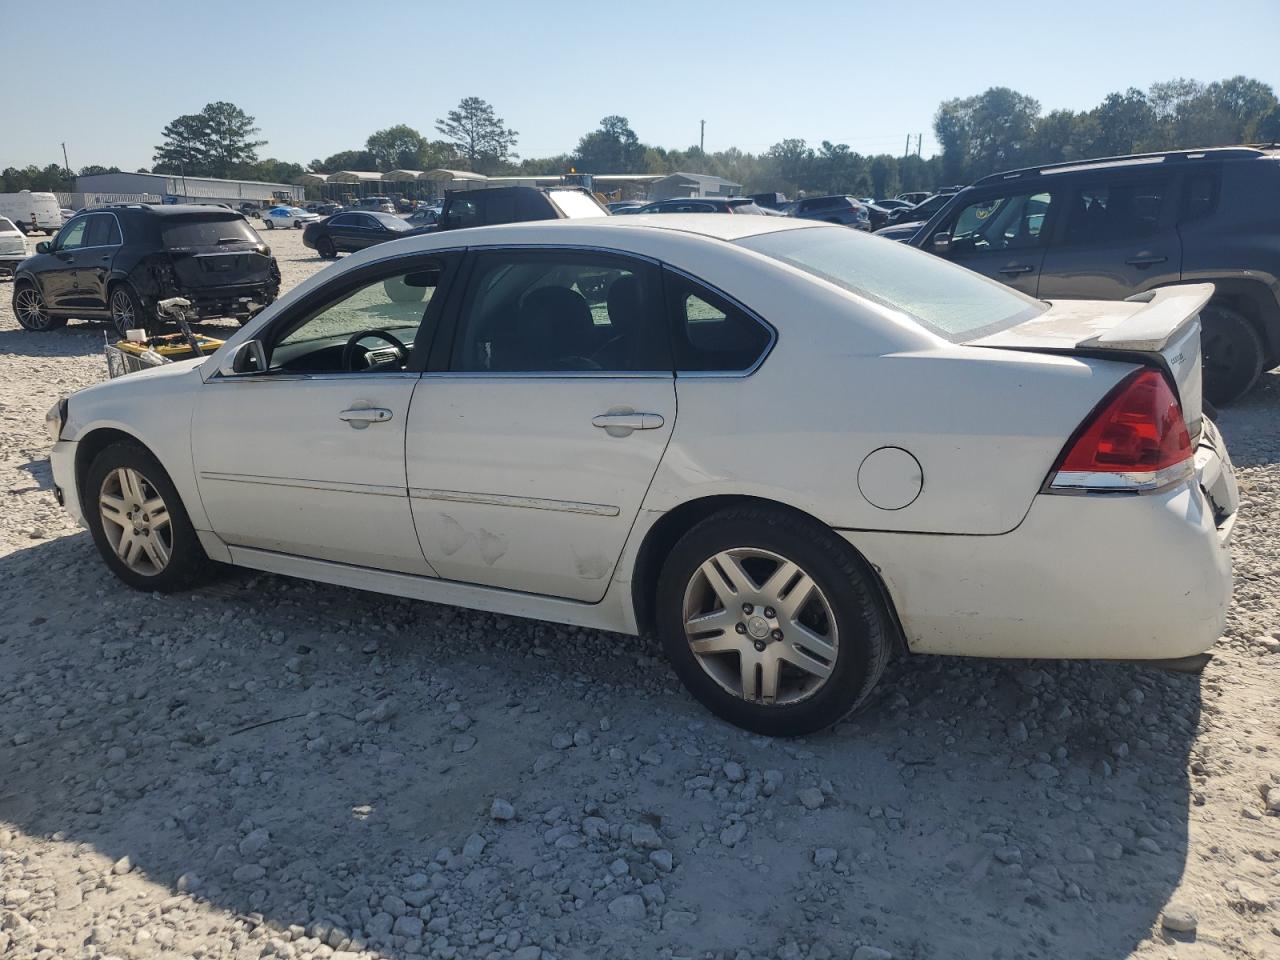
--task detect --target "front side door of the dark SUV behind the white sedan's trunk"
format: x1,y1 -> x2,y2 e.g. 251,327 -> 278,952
924,188 -> 1053,297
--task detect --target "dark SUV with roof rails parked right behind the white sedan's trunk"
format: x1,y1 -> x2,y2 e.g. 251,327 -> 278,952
908,147 -> 1280,404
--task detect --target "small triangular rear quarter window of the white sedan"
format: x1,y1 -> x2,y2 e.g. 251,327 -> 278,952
666,271 -> 773,374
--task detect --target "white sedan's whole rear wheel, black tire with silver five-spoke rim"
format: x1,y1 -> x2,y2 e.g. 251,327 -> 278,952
657,507 -> 893,736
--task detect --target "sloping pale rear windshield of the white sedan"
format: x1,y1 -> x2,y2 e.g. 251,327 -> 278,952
737,227 -> 1048,343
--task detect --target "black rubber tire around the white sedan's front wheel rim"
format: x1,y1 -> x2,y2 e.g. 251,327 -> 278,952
81,443 -> 210,593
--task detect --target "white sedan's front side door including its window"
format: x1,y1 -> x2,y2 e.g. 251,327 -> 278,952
192,256 -> 453,576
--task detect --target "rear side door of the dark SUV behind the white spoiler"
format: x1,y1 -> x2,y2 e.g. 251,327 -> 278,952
1039,174 -> 1183,300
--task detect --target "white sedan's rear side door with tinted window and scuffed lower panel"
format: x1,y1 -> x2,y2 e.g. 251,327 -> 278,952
406,250 -> 676,602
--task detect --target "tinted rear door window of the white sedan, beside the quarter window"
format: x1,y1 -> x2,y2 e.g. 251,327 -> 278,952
451,251 -> 671,374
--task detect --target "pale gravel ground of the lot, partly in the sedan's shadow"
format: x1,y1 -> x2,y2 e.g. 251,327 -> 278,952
0,227 -> 1280,960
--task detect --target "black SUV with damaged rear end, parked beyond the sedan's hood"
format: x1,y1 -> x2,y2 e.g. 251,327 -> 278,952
13,204 -> 280,335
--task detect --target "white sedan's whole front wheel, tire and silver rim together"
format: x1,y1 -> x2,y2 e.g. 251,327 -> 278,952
82,443 -> 209,593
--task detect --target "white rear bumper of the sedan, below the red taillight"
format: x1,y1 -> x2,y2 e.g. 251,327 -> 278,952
845,430 -> 1236,660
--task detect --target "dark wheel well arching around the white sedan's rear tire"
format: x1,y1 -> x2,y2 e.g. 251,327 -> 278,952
631,495 -> 908,653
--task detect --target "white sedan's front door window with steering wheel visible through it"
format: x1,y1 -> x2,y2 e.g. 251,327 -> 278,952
268,262 -> 443,372
